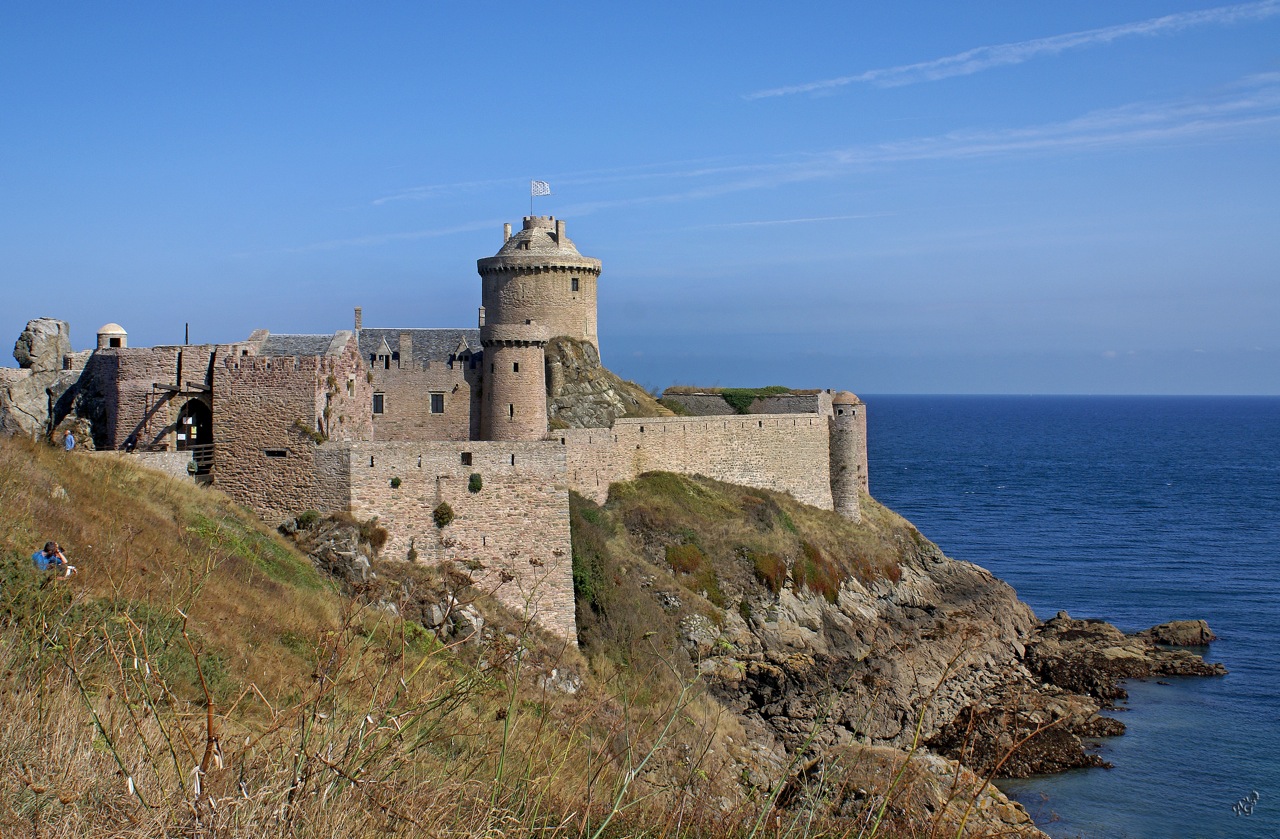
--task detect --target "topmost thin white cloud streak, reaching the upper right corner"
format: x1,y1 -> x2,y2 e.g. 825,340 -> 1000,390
744,0 -> 1280,100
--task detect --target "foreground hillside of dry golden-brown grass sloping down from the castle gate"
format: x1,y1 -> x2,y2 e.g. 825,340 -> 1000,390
0,438 -> 751,836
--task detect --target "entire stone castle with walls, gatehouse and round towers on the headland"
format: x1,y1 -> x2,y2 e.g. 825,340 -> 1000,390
0,216 -> 868,639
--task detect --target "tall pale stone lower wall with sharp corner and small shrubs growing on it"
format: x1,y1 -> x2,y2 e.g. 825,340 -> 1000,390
349,441 -> 577,639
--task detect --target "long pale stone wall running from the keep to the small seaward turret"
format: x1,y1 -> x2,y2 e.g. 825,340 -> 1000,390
556,414 -> 832,510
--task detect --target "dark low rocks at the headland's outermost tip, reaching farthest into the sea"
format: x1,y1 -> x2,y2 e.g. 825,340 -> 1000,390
1027,612 -> 1226,703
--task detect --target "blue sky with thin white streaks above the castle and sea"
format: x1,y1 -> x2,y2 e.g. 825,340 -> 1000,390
0,0 -> 1280,395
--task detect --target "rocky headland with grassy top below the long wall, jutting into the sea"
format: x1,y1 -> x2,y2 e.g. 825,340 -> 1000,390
573,473 -> 1224,835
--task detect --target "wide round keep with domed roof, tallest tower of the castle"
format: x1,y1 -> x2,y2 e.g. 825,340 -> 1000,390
476,215 -> 600,351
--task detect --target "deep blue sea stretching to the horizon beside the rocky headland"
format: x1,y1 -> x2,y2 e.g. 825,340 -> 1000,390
863,396 -> 1280,839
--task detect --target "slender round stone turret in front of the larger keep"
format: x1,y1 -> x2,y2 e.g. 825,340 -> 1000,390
480,323 -> 550,439
